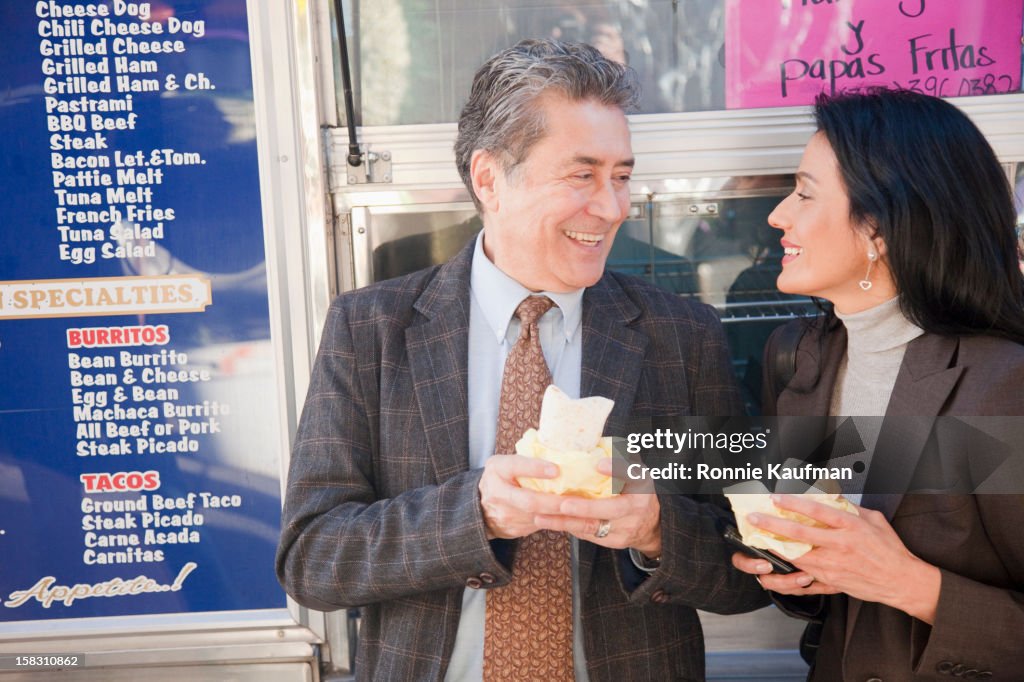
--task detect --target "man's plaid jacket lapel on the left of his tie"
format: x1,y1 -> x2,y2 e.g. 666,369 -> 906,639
406,240 -> 475,483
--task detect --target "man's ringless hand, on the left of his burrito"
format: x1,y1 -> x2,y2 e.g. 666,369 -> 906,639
477,455 -> 564,540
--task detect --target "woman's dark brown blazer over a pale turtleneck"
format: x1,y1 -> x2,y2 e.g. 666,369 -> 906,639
765,322 -> 1024,682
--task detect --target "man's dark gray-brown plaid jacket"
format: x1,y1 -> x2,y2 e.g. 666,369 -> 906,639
276,237 -> 767,682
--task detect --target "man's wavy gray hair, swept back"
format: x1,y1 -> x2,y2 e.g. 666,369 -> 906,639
455,40 -> 640,211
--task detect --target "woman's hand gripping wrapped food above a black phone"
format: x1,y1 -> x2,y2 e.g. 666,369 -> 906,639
733,495 -> 941,623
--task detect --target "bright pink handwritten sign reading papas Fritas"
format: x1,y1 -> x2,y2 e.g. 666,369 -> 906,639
725,0 -> 1024,109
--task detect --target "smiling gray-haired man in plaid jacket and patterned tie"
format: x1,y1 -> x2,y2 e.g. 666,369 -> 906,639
278,41 -> 765,682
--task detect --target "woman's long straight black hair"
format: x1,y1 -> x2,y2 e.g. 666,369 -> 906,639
814,88 -> 1024,343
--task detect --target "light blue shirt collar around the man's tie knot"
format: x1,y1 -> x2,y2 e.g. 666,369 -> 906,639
469,231 -> 584,343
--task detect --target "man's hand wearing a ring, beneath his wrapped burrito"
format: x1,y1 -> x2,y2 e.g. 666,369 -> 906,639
535,459 -> 662,558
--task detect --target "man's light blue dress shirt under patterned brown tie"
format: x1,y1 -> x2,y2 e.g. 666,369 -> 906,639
444,232 -> 588,682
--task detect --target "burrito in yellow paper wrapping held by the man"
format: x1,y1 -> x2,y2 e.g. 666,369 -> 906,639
515,384 -> 615,499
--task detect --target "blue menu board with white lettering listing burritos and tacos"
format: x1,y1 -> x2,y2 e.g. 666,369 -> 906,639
0,0 -> 286,618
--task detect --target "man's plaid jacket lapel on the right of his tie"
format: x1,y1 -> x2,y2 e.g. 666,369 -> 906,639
579,273 -> 648,590
